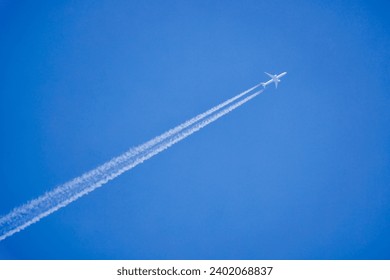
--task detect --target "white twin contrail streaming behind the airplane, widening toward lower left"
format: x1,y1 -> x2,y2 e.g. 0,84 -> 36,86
0,84 -> 264,241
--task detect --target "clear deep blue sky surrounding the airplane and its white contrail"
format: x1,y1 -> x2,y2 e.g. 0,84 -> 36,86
0,1 -> 390,259
